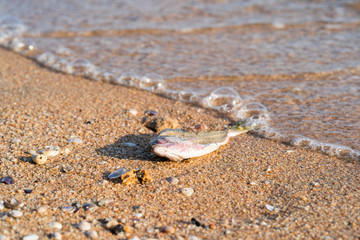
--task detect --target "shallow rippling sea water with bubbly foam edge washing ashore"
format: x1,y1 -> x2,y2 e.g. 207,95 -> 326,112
0,0 -> 360,159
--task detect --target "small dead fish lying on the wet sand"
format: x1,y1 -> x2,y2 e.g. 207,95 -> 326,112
150,122 -> 251,162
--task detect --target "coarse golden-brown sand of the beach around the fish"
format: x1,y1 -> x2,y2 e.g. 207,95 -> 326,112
0,49 -> 360,239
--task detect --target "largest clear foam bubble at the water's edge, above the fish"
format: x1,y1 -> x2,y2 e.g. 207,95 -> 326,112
203,87 -> 243,112
